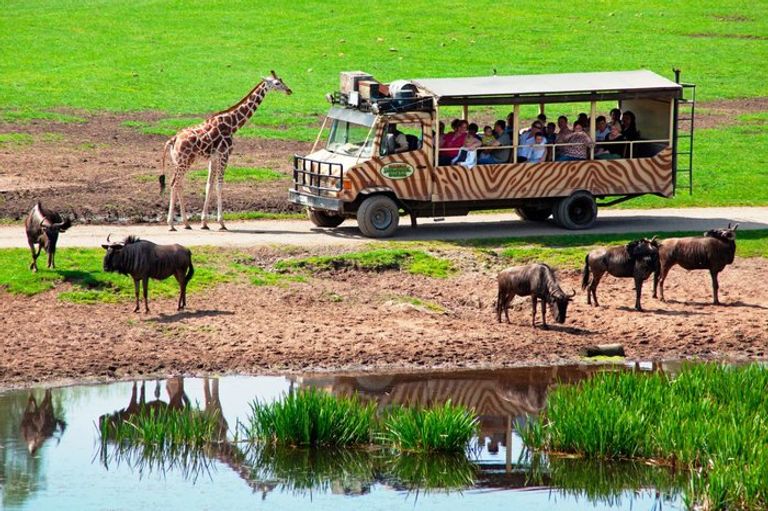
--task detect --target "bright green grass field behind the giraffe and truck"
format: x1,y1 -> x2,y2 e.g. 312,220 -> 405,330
0,0 -> 768,207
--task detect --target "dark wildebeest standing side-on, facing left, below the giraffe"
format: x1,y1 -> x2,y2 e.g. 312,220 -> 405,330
102,236 -> 195,312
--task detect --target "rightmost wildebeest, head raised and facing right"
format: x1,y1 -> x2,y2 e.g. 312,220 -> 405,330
653,223 -> 739,305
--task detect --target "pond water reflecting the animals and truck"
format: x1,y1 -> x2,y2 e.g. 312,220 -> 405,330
0,364 -> 686,511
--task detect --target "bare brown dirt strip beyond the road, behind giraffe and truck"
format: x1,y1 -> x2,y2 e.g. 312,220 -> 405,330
0,98 -> 768,223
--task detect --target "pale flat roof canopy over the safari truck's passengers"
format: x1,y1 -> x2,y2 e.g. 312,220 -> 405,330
412,69 -> 682,105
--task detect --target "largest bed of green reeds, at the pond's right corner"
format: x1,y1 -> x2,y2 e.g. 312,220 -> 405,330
522,364 -> 768,510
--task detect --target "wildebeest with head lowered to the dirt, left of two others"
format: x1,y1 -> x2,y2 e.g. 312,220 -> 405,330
496,263 -> 576,328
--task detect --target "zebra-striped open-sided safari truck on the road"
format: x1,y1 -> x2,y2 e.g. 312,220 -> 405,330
289,70 -> 695,238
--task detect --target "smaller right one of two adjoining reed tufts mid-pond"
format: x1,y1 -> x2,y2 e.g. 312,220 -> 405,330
381,400 -> 478,452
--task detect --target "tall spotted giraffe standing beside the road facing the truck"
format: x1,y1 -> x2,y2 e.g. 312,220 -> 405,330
160,71 -> 292,231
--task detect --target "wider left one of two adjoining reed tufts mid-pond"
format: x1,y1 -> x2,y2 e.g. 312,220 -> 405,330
244,388 -> 376,446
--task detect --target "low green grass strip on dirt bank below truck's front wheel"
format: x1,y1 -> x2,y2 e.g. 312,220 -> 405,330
275,249 -> 456,278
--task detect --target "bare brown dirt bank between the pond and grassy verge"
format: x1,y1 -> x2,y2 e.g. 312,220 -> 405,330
0,254 -> 768,387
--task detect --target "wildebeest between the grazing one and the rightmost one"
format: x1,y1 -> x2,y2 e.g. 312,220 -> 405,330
581,236 -> 659,311
